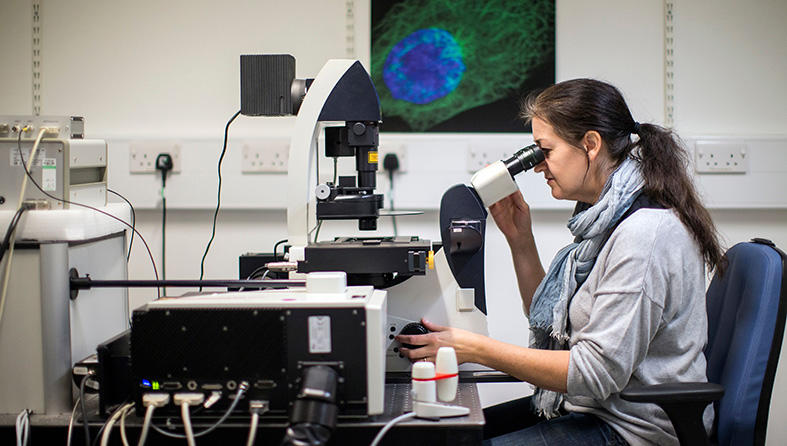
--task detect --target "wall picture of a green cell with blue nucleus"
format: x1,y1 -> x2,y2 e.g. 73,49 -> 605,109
371,0 -> 555,132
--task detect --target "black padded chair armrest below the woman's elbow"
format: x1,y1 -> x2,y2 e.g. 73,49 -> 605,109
620,382 -> 724,405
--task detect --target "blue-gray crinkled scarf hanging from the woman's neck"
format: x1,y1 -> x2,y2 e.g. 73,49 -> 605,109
530,158 -> 644,418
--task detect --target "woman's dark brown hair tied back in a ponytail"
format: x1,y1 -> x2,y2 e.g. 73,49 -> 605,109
520,79 -> 724,271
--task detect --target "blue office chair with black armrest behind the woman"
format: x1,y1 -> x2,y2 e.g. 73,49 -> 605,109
621,239 -> 787,446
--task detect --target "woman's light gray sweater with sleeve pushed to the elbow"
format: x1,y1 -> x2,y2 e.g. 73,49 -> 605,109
565,209 -> 713,445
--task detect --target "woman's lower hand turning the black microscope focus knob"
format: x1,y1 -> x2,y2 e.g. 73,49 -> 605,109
396,319 -> 487,364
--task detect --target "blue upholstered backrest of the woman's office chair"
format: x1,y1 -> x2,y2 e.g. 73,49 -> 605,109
705,239 -> 787,446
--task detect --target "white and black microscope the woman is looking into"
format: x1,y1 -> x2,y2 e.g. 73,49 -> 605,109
241,55 -> 544,372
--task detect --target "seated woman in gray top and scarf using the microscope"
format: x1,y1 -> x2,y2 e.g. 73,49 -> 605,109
398,79 -> 722,445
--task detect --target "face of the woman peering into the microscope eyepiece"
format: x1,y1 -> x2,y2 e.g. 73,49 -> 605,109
532,117 -> 600,203
